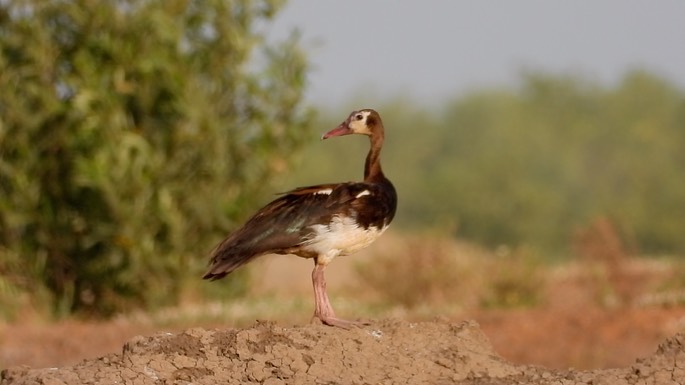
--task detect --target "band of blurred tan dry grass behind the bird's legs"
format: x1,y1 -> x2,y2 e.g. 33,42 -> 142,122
6,232 -> 685,326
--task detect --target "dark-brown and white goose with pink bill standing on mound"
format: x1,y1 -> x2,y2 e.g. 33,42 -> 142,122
203,108 -> 397,329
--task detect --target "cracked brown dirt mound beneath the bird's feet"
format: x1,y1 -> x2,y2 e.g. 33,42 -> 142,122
0,321 -> 685,385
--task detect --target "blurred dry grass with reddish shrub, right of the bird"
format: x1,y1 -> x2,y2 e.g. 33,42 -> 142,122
343,228 -> 685,315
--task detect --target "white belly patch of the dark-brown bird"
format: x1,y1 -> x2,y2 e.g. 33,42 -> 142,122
306,216 -> 387,264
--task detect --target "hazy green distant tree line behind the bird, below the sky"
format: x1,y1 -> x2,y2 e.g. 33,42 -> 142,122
298,71 -> 685,256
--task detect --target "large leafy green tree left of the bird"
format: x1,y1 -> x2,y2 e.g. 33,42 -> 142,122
0,0 -> 310,315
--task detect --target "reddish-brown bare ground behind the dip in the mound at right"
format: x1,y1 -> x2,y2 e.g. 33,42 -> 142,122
475,307 -> 685,369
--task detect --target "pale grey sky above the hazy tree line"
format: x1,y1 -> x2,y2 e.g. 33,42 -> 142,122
268,0 -> 685,107
